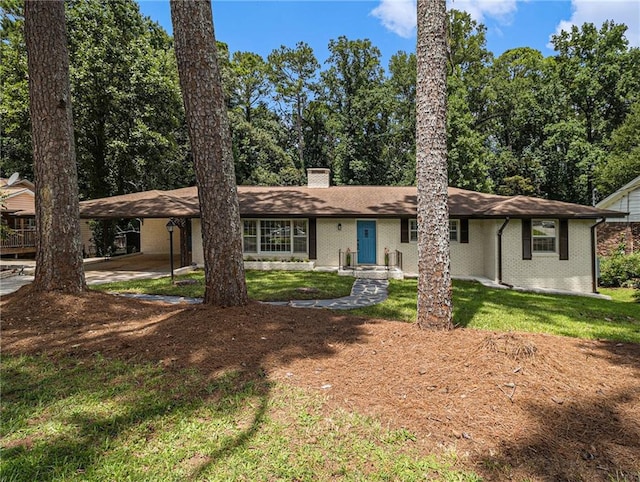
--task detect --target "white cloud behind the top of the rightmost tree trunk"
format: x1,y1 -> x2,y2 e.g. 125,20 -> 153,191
371,0 -> 517,38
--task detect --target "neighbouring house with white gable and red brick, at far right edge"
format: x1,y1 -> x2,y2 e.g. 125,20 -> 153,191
596,176 -> 640,256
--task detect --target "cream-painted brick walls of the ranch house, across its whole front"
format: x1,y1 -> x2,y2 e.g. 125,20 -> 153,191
168,219 -> 593,292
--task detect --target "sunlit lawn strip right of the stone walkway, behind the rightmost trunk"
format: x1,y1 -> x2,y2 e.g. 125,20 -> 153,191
353,279 -> 640,343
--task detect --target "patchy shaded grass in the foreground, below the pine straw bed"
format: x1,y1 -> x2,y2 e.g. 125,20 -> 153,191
0,355 -> 479,482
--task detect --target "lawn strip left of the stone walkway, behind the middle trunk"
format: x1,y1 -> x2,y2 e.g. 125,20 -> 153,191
91,270 -> 353,301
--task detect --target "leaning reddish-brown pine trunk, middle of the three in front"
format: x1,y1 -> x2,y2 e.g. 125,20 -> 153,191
171,0 -> 248,306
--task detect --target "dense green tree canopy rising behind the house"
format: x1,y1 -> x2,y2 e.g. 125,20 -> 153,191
0,0 -> 640,203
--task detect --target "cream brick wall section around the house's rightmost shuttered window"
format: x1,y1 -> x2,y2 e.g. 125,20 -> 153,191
502,219 -> 594,293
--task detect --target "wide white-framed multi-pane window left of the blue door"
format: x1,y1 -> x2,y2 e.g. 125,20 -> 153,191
243,219 -> 308,254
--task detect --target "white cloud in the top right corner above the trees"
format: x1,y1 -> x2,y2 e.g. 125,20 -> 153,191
549,0 -> 640,48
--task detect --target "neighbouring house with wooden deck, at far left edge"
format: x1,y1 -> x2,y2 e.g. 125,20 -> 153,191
0,174 -> 36,256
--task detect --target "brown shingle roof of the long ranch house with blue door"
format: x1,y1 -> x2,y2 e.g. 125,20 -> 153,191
80,186 -> 624,219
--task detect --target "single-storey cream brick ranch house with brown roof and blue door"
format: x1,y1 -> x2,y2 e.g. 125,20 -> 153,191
80,169 -> 623,292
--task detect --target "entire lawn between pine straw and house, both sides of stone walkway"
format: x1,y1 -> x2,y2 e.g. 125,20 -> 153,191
94,271 -> 640,343
